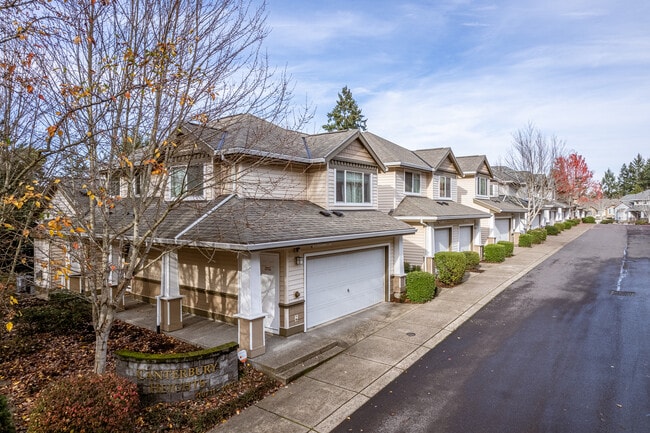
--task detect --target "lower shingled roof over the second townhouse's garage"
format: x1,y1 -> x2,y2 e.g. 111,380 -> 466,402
391,196 -> 490,221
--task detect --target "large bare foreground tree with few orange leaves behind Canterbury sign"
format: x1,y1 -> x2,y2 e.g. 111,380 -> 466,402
27,0 -> 290,372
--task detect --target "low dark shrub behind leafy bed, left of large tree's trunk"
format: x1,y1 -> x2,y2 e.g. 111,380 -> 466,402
18,292 -> 92,334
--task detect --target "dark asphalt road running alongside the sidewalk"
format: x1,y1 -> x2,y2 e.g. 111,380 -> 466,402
334,225 -> 650,433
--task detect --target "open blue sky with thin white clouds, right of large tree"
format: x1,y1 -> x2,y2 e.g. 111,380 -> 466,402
265,0 -> 650,180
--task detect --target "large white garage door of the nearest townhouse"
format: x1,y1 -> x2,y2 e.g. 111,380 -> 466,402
305,248 -> 386,328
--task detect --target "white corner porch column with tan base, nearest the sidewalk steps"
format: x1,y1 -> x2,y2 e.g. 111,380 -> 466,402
235,252 -> 266,358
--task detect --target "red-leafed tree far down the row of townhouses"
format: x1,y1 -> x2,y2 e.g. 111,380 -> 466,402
552,153 -> 600,218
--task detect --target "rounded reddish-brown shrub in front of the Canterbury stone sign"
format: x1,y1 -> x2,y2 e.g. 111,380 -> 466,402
27,374 -> 140,433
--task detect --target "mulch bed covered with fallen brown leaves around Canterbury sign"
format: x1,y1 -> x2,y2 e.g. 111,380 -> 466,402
0,298 -> 281,433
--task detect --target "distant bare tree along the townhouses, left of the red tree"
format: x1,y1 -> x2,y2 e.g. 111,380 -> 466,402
505,123 -> 564,230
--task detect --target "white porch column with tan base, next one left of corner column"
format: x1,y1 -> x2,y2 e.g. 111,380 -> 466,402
156,251 -> 183,332
